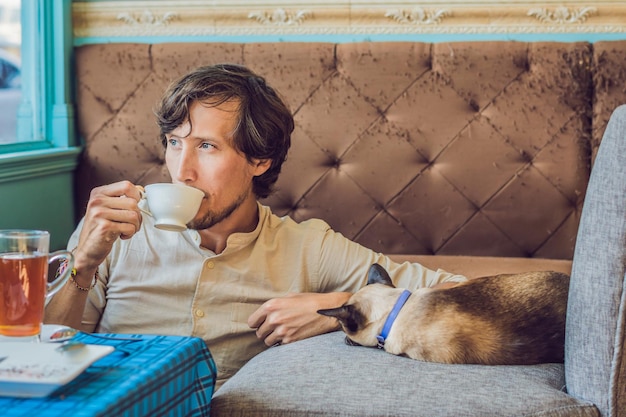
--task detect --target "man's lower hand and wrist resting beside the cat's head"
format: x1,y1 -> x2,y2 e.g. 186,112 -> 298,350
248,292 -> 352,346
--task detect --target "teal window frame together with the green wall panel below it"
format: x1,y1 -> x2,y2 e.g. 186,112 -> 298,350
0,0 -> 82,250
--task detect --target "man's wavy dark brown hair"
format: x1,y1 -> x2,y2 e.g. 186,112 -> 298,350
155,64 -> 294,198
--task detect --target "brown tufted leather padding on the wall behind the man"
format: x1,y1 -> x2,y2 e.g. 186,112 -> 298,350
76,42 -> 626,259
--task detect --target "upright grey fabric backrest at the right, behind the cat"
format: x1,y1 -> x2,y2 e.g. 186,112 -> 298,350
565,106 -> 626,417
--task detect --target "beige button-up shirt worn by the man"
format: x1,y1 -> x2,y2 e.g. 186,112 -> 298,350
68,204 -> 465,386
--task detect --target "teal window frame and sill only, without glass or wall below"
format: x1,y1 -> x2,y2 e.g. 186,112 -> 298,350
0,0 -> 80,162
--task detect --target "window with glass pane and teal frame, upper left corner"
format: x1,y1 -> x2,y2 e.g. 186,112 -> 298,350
0,0 -> 76,154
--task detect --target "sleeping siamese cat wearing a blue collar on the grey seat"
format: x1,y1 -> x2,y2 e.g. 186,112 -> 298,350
318,264 -> 569,365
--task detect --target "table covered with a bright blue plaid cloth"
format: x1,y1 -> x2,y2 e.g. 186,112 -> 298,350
0,333 -> 217,417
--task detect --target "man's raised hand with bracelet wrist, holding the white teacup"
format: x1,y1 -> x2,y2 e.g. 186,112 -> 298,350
75,181 -> 142,268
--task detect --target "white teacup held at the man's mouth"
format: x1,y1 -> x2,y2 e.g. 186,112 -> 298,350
143,183 -> 204,232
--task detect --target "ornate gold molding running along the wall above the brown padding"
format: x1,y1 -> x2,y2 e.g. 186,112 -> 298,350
72,0 -> 626,38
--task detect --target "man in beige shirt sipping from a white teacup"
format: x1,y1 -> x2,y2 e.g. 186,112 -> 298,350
46,65 -> 465,387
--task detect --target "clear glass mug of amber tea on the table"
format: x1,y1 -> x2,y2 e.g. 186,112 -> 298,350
0,230 -> 74,342
